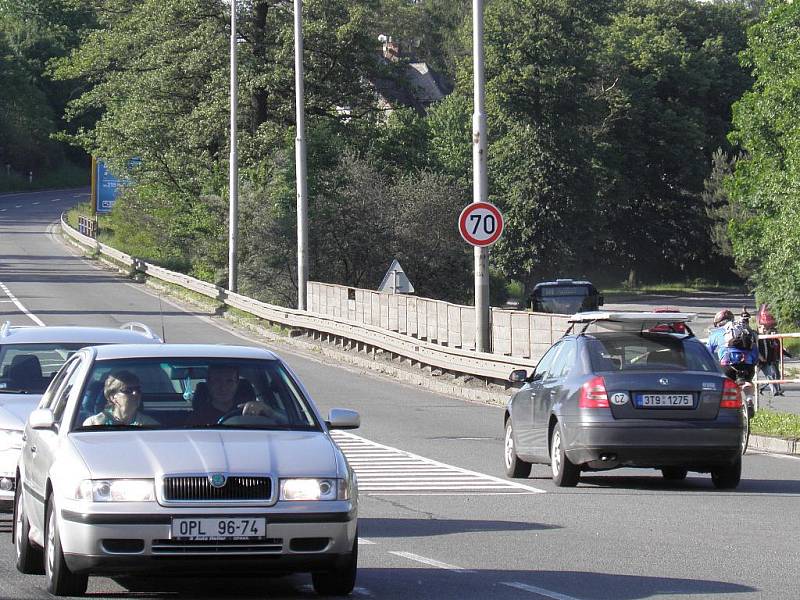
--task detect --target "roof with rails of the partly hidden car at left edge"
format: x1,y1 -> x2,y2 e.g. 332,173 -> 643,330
0,323 -> 161,346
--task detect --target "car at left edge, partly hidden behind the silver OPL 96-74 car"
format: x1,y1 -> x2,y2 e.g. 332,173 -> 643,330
0,323 -> 161,509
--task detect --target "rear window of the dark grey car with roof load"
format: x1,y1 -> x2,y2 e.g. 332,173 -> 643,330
587,331 -> 719,372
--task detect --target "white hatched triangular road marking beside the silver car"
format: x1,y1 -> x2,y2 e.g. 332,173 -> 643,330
331,431 -> 544,496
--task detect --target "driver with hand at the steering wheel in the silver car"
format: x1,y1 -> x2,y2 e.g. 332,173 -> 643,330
188,365 -> 286,425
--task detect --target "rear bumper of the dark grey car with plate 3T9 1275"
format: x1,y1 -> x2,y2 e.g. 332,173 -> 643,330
564,420 -> 743,471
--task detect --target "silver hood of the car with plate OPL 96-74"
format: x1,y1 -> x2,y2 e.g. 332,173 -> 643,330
70,429 -> 337,478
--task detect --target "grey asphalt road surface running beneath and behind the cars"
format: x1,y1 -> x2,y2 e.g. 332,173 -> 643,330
0,192 -> 800,600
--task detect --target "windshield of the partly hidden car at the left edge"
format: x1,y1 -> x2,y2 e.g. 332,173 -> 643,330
0,343 -> 86,394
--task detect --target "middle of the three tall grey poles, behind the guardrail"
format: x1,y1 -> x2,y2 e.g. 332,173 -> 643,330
294,0 -> 308,310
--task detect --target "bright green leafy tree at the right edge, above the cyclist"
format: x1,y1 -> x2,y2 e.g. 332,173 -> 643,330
728,1 -> 800,326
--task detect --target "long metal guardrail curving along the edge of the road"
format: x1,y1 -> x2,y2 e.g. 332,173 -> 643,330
61,215 -> 532,380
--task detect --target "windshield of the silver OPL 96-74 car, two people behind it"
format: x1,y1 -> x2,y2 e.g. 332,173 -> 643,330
72,358 -> 320,431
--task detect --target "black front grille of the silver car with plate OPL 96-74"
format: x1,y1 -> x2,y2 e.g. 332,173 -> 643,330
164,475 -> 272,502
